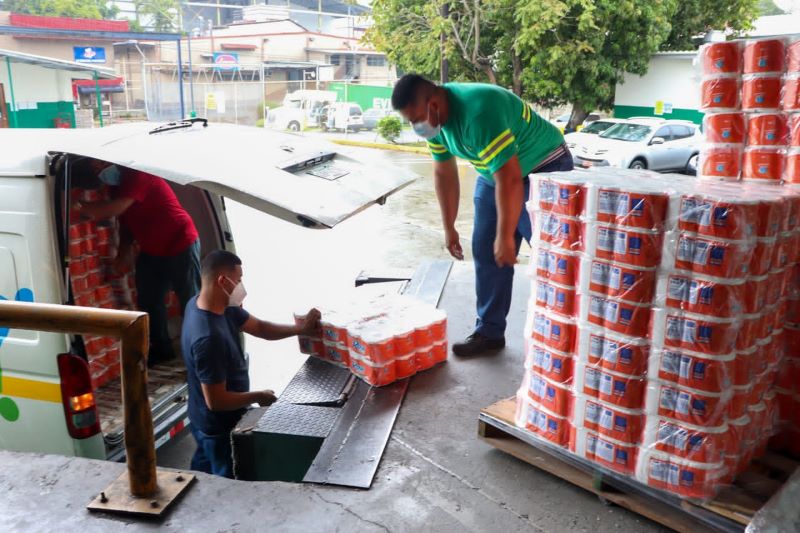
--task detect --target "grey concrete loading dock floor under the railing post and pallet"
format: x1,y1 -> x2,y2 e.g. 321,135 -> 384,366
0,263 -> 661,532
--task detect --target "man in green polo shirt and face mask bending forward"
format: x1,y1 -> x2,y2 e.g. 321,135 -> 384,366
392,74 -> 573,356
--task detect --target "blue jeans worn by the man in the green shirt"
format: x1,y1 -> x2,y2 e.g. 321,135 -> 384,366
472,150 -> 574,339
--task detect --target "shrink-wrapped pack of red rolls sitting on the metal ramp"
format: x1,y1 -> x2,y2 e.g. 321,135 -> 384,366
295,295 -> 447,387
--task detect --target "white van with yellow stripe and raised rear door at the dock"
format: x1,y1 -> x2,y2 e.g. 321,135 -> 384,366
0,119 -> 415,459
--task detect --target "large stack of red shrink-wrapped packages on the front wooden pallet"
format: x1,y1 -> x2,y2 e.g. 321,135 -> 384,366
516,169 -> 800,499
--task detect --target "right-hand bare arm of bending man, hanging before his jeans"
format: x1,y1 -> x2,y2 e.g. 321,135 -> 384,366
494,155 -> 525,267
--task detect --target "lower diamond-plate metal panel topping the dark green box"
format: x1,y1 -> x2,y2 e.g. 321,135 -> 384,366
253,403 -> 341,438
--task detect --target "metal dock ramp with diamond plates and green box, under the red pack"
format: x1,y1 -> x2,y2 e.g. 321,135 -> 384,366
232,261 -> 452,489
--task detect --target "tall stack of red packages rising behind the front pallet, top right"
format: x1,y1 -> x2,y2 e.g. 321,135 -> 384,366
698,37 -> 800,183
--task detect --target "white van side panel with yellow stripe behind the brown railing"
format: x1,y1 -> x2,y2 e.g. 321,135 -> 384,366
0,176 -> 104,457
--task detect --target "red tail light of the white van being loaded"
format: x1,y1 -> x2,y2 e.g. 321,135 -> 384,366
58,353 -> 100,439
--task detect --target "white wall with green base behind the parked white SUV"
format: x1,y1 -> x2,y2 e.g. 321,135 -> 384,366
614,54 -> 703,124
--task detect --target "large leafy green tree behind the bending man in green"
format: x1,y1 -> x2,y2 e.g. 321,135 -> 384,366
367,0 -> 759,127
